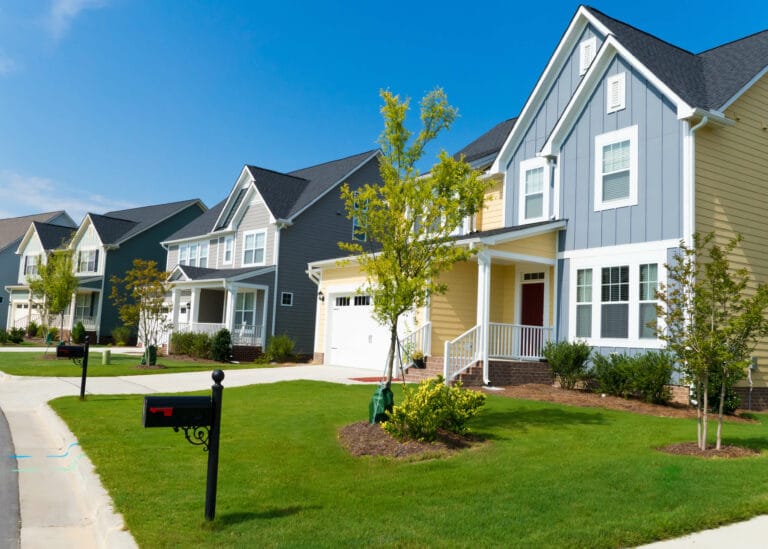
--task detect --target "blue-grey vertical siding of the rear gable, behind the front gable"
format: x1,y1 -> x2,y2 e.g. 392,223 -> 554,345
504,25 -> 605,226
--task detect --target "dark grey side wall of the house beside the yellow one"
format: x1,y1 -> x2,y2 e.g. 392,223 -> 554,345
275,158 -> 381,354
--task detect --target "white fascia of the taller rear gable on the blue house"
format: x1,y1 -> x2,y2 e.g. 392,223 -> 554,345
490,6 -> 611,173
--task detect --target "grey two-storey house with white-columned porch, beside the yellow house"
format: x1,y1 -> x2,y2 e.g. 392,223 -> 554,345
163,150 -> 379,359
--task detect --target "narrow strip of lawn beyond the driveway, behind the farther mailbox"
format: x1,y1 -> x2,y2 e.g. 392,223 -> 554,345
0,347 -> 270,377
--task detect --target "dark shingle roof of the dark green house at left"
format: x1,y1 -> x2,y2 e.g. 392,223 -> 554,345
86,198 -> 205,245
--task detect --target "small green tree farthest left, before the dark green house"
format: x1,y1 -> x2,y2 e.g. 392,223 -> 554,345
27,249 -> 79,334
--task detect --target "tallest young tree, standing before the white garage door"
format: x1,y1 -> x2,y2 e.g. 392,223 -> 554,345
339,88 -> 488,388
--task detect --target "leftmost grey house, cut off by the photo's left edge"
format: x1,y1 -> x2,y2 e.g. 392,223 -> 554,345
0,211 -> 77,328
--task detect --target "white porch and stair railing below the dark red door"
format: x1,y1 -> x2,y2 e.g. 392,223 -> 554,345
443,322 -> 554,382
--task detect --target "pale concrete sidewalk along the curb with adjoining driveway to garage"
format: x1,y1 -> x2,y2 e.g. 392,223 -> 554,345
0,356 -> 378,549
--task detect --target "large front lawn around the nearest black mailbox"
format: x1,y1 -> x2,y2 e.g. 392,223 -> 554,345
52,381 -> 768,548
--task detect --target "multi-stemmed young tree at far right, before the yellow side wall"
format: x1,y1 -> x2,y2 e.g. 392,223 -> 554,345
656,233 -> 768,450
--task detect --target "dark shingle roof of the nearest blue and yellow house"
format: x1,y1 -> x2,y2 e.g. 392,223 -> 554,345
586,7 -> 768,109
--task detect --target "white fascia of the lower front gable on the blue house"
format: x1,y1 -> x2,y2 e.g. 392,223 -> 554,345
539,35 -> 694,157
